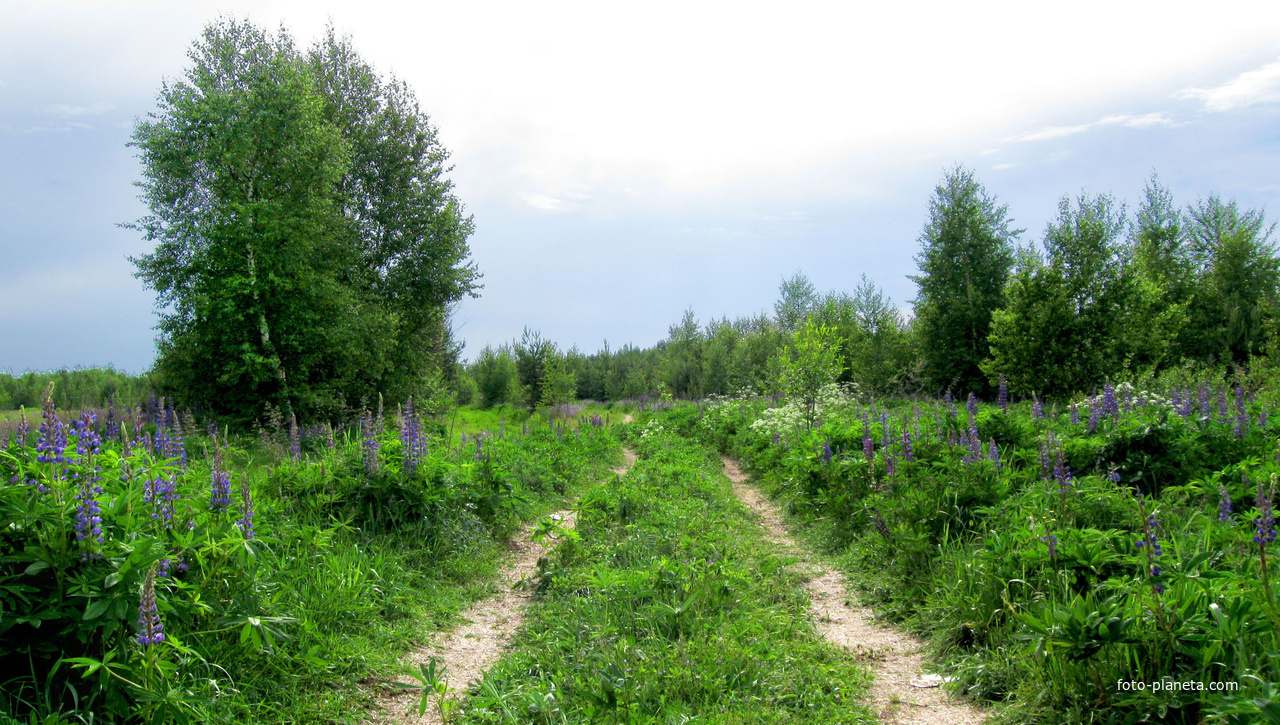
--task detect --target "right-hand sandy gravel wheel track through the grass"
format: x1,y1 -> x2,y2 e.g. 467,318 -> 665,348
723,459 -> 987,725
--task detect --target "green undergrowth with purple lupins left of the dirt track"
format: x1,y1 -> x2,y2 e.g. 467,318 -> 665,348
0,397 -> 617,722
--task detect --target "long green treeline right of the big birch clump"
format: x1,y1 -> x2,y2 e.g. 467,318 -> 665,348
460,168 -> 1280,405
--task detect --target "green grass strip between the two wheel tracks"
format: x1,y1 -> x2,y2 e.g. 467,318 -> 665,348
453,422 -> 874,724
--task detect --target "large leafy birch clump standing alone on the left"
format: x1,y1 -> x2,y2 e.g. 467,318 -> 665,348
132,19 -> 476,420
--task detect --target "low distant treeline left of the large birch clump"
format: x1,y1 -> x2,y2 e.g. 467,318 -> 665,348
0,368 -> 151,410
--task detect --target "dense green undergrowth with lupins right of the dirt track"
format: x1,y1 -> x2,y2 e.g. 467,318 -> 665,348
686,380 -> 1280,725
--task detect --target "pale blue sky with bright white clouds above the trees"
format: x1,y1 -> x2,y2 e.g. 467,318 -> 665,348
0,0 -> 1280,373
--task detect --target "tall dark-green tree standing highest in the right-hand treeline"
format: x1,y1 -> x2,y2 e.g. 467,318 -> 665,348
911,167 -> 1021,393
